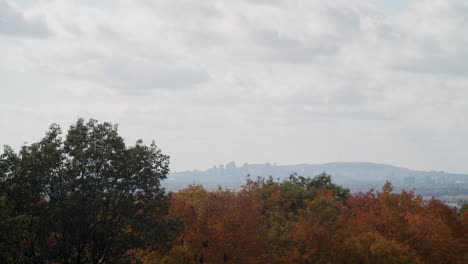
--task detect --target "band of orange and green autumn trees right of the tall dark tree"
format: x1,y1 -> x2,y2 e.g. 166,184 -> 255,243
137,174 -> 468,264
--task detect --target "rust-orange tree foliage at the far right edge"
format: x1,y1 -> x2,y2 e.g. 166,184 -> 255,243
341,184 -> 464,263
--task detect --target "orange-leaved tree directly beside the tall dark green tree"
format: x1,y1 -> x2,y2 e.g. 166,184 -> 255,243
165,187 -> 265,263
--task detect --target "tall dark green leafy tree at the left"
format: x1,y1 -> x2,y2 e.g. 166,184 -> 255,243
0,119 -> 181,263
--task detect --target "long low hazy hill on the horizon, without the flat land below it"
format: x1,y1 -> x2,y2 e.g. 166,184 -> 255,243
167,162 -> 468,186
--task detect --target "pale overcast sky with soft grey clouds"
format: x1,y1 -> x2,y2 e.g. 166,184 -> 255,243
0,0 -> 468,173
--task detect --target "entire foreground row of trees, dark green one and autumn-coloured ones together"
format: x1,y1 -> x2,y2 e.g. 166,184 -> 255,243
0,119 -> 468,264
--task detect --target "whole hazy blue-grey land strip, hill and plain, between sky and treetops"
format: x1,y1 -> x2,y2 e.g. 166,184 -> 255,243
163,162 -> 468,203
